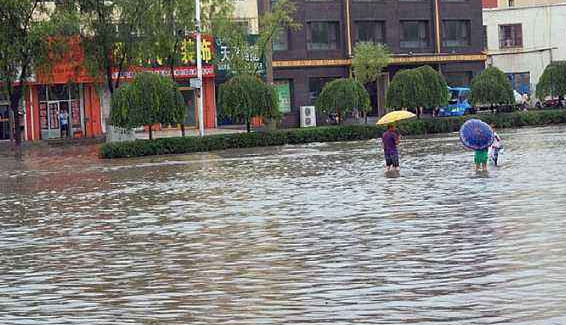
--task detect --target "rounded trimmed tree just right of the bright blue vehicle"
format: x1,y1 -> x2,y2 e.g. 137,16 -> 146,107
470,67 -> 515,107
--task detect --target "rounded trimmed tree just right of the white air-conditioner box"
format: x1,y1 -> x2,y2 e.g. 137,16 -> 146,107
315,78 -> 371,123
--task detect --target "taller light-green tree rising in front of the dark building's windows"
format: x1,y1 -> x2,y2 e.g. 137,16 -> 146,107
352,42 -> 391,85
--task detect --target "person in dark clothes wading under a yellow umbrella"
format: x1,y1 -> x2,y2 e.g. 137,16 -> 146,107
377,111 -> 416,173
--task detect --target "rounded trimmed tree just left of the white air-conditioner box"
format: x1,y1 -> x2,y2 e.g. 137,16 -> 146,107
219,74 -> 281,132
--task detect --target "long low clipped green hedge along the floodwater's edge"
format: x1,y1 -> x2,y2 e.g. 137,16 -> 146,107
100,110 -> 566,158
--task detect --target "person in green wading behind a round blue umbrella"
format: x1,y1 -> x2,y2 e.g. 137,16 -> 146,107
460,119 -> 495,171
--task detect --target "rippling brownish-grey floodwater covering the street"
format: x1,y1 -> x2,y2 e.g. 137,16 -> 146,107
0,128 -> 566,325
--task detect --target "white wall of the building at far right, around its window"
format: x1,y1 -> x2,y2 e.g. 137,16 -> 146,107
483,4 -> 566,90
